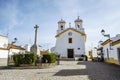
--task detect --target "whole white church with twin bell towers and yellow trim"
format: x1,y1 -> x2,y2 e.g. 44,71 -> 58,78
52,17 -> 86,59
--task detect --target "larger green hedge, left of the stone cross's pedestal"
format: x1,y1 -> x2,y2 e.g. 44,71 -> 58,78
13,53 -> 36,66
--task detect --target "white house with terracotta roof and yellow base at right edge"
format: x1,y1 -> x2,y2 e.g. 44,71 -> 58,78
102,34 -> 120,64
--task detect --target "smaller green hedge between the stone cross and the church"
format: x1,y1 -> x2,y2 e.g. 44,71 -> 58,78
42,53 -> 56,63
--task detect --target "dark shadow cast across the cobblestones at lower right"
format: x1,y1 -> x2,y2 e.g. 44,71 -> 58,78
54,61 -> 120,80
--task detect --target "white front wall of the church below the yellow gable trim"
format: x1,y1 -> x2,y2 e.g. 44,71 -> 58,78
55,30 -> 85,57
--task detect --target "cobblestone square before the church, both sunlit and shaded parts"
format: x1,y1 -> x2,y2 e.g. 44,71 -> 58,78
0,61 -> 120,80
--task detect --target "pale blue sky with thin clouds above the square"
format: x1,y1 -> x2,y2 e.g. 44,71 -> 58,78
0,0 -> 120,49
